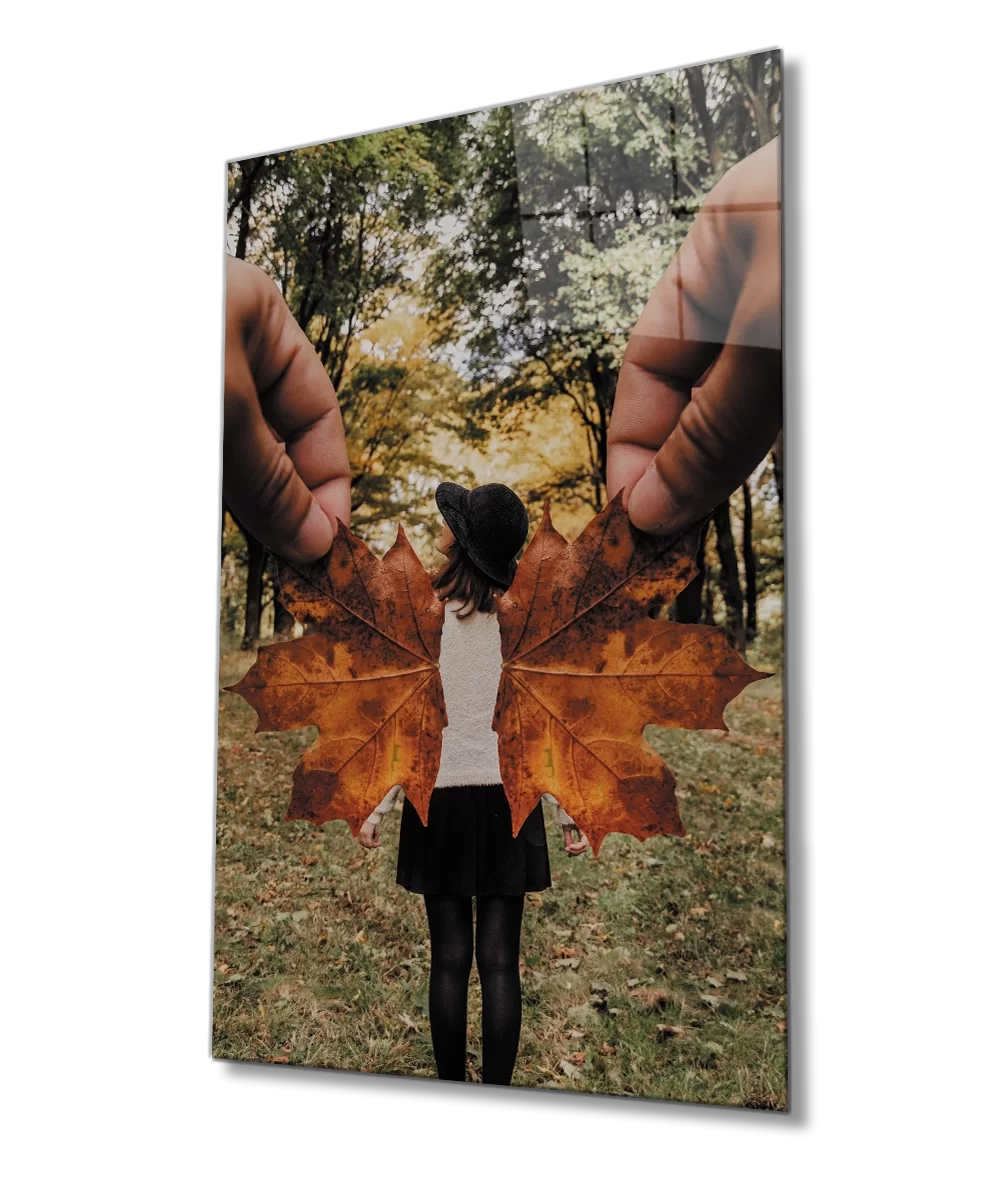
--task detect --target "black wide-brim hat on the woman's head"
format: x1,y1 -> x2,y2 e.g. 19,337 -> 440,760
435,484 -> 528,592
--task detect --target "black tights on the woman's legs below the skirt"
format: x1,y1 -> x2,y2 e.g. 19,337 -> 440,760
424,895 -> 525,1086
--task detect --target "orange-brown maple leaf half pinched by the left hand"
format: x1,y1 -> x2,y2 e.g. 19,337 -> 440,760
227,524 -> 447,836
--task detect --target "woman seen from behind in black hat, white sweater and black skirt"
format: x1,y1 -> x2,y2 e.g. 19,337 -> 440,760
358,484 -> 587,1086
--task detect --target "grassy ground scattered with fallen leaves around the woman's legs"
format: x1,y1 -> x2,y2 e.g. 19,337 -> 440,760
214,624 -> 786,1109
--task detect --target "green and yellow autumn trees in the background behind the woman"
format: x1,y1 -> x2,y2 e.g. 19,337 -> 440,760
222,54 -> 783,643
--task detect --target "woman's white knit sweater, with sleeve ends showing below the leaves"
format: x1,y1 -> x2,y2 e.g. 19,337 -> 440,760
372,601 -> 573,826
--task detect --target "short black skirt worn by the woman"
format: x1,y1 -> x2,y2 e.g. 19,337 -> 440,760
396,784 -> 552,896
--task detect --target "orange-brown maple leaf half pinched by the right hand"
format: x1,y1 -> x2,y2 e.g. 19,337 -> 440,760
493,496 -> 766,854
